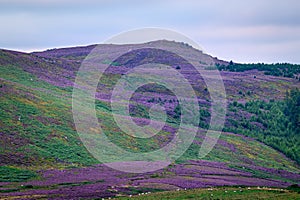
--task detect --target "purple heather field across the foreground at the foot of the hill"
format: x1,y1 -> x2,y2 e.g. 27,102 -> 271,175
0,161 -> 300,199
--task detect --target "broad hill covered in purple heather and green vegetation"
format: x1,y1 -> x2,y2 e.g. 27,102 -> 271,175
0,41 -> 300,199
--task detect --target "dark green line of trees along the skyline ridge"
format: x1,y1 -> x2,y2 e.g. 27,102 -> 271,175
216,61 -> 300,80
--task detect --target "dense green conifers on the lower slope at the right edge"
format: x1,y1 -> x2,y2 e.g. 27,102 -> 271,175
225,89 -> 300,164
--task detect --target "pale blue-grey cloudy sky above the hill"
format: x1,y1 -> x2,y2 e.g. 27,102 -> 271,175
0,0 -> 300,64
